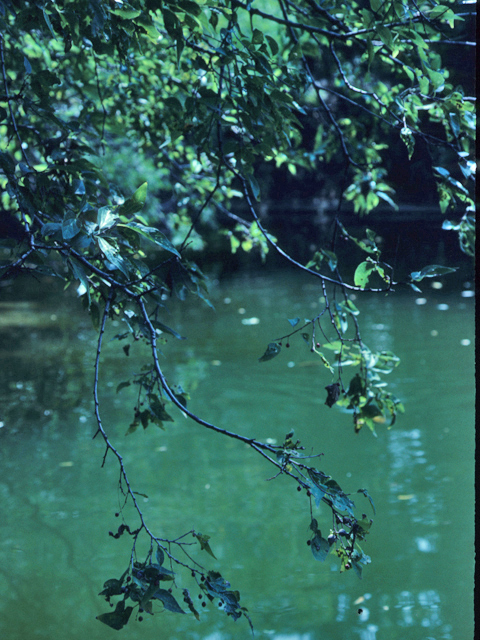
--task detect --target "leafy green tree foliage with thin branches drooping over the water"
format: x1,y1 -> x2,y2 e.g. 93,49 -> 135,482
0,0 -> 474,629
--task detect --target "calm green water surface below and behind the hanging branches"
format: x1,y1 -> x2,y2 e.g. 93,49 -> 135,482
0,274 -> 474,640
